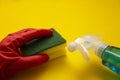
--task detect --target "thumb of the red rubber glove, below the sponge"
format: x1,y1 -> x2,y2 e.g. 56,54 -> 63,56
6,54 -> 49,77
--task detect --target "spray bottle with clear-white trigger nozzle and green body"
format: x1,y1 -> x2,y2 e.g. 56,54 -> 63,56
68,35 -> 120,75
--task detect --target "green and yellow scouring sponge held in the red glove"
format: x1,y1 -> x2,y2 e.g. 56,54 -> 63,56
21,28 -> 66,56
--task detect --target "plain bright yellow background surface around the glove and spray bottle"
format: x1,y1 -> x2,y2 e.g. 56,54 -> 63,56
0,0 -> 120,80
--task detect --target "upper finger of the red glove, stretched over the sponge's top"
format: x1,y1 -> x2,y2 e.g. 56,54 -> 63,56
1,28 -> 52,51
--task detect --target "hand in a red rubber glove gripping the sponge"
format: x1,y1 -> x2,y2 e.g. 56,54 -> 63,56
0,28 -> 52,80
